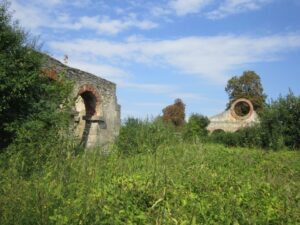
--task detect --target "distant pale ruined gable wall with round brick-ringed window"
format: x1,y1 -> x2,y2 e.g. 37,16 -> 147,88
207,98 -> 259,132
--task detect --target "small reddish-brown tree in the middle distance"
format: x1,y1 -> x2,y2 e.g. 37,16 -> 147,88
162,99 -> 185,127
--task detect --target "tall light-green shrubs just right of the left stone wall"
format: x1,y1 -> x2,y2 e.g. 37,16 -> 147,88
116,118 -> 181,155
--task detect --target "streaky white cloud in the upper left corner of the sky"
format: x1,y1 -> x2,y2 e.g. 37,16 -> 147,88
11,0 -> 158,35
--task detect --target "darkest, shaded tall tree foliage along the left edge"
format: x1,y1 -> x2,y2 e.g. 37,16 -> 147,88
0,4 -> 41,148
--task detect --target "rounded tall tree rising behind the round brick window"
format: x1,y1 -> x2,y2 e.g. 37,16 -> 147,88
225,71 -> 266,112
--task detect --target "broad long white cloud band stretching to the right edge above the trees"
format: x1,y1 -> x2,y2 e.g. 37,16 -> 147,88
49,34 -> 300,84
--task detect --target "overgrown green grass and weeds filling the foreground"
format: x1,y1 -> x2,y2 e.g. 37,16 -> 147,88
0,144 -> 300,224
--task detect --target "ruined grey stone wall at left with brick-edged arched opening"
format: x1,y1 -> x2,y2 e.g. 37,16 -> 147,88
45,56 -> 120,148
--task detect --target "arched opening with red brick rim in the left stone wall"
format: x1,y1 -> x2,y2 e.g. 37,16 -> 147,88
75,85 -> 100,147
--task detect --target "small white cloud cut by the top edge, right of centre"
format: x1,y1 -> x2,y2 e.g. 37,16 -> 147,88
170,0 -> 213,16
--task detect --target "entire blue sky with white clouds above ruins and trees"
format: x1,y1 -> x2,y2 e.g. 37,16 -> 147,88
7,0 -> 300,118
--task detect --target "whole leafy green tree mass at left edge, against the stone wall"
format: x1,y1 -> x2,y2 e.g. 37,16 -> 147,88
0,3 -> 72,151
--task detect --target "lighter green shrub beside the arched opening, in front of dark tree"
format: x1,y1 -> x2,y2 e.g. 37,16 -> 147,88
5,75 -> 73,175
